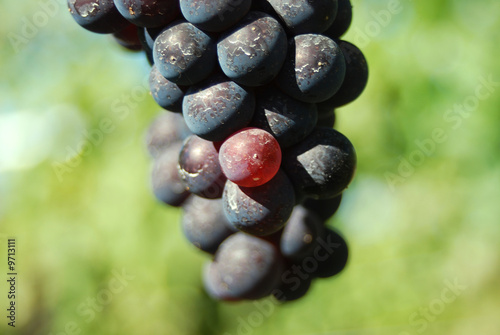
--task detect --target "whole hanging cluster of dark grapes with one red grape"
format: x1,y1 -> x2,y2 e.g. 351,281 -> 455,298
68,0 -> 368,301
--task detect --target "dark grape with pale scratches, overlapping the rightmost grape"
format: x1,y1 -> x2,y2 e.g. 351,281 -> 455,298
276,34 -> 345,102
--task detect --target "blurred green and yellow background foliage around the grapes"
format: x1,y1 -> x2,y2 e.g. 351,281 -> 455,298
0,0 -> 500,335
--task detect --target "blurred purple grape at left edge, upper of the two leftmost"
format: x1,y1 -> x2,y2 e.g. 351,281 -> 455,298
146,112 -> 191,158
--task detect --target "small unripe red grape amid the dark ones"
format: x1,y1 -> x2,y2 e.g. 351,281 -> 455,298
219,128 -> 281,187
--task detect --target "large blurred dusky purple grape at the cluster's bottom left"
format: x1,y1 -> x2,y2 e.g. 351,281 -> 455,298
204,233 -> 284,300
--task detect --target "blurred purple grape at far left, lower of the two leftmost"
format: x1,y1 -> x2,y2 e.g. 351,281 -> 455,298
151,142 -> 190,206
